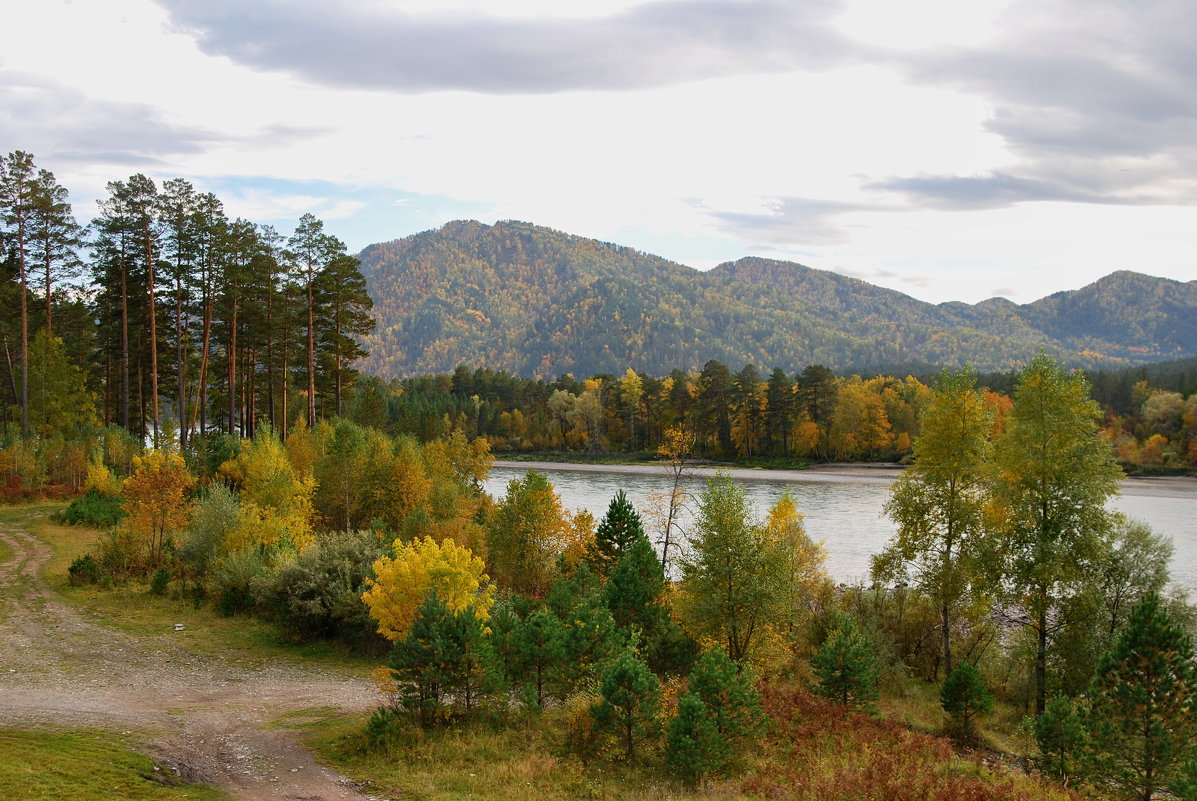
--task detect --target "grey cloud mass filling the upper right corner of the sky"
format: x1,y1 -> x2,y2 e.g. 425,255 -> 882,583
868,0 -> 1197,210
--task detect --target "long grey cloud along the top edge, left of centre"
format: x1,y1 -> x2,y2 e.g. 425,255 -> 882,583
157,0 -> 856,95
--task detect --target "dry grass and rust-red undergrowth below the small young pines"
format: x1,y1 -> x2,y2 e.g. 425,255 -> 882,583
296,685 -> 1081,801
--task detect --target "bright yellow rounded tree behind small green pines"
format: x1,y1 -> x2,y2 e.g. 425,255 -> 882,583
361,536 -> 494,642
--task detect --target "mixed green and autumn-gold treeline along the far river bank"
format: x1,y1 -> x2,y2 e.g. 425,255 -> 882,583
350,359 -> 1197,469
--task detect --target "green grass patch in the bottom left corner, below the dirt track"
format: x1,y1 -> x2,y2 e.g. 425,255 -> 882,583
0,729 -> 229,801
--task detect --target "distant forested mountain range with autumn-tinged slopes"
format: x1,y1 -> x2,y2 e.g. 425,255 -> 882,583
360,222 -> 1197,378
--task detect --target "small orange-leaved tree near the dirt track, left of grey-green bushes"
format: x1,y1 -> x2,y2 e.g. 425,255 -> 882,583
122,450 -> 195,568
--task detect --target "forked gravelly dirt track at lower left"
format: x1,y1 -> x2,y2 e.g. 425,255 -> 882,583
0,512 -> 377,801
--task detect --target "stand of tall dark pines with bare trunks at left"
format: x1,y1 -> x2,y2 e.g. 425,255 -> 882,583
0,151 -> 373,444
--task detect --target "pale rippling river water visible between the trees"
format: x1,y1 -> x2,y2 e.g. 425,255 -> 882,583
485,462 -> 1197,597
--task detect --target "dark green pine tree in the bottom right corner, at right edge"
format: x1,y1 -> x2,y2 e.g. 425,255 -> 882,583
1088,593 -> 1197,801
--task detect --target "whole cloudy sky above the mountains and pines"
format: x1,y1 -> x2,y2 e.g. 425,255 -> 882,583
0,0 -> 1197,303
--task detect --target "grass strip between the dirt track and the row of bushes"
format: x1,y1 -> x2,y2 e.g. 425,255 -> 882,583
18,504 -> 377,681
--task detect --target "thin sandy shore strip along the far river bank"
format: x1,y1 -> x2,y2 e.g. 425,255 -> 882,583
494,460 -> 1197,498
